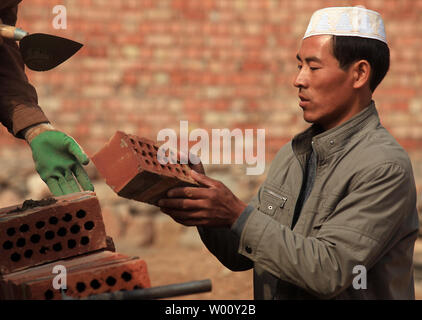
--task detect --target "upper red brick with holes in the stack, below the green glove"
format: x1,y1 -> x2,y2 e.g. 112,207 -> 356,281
0,191 -> 110,274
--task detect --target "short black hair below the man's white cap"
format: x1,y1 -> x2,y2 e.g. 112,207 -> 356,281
333,35 -> 390,92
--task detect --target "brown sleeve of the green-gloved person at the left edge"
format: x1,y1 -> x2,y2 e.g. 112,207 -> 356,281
0,1 -> 48,138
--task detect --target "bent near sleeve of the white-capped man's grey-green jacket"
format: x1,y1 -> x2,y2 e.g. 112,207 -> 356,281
239,163 -> 416,298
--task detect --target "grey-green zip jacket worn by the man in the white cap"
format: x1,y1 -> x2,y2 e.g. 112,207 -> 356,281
198,102 -> 418,299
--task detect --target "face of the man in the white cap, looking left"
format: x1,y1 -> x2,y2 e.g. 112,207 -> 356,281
294,35 -> 354,130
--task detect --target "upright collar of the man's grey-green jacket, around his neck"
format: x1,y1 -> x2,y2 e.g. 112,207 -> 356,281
292,101 -> 380,159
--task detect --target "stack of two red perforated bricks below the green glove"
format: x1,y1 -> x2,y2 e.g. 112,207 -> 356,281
0,192 -> 150,299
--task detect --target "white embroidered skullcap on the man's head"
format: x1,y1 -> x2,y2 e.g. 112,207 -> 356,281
303,6 -> 387,43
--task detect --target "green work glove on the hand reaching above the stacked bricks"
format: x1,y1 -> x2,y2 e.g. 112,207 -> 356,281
30,131 -> 94,196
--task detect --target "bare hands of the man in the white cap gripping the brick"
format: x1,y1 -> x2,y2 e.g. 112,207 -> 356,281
158,170 -> 247,227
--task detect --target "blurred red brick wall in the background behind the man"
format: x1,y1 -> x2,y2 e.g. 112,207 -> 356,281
0,0 -> 422,188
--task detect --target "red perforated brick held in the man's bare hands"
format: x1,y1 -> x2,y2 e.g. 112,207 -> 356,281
92,131 -> 199,205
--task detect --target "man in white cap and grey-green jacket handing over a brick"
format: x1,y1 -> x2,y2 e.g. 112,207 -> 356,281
160,7 -> 418,299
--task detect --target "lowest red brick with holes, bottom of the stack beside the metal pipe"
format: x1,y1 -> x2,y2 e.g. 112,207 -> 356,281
0,251 -> 151,300
